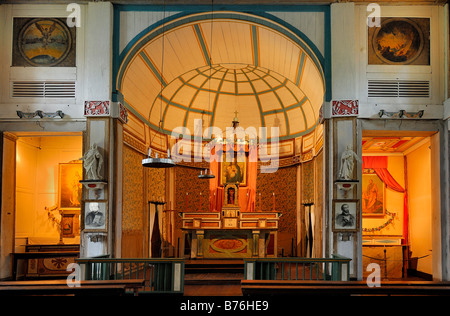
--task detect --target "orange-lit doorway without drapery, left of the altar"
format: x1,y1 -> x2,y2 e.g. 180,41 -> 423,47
10,132 -> 83,278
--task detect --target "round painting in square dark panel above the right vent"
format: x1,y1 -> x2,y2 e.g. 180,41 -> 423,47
368,17 -> 430,65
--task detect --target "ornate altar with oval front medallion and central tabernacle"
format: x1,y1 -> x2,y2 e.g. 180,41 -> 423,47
180,185 -> 281,259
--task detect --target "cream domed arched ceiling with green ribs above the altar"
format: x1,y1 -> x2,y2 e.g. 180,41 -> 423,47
117,12 -> 325,139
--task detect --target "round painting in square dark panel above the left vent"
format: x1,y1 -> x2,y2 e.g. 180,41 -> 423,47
12,18 -> 76,67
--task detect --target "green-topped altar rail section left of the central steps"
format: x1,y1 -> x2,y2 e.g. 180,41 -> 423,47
76,257 -> 184,294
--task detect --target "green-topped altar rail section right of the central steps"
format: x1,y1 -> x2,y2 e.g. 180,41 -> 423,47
244,255 -> 351,281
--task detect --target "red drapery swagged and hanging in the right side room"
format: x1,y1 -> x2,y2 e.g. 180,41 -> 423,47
363,156 -> 408,243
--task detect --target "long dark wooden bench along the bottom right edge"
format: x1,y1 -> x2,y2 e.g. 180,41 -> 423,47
241,280 -> 450,296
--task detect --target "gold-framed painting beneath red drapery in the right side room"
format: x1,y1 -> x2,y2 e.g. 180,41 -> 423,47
361,169 -> 385,216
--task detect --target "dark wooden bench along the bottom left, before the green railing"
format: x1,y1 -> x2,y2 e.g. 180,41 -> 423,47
0,279 -> 145,295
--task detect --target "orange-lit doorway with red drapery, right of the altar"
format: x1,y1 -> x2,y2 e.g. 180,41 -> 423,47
361,131 -> 440,280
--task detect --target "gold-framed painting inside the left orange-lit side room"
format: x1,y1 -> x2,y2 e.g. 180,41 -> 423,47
58,161 -> 83,210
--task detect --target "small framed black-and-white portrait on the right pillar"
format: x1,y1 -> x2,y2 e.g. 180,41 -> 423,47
333,200 -> 359,232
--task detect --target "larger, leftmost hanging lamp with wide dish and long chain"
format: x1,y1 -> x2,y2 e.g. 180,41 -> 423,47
142,1 -> 175,168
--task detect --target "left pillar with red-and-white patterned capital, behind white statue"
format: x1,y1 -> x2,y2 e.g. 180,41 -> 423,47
80,100 -> 127,257
